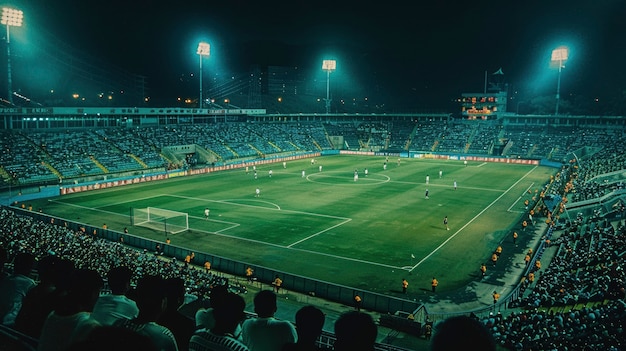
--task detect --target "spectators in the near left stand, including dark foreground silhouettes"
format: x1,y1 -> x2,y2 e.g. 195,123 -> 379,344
0,208 -> 377,351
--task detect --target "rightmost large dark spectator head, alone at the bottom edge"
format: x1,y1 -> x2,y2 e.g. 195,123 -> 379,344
430,316 -> 496,351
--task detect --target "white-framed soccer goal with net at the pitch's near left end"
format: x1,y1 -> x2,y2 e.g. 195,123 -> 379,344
130,207 -> 189,234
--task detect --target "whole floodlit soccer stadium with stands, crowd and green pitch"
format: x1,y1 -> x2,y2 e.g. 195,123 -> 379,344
0,2 -> 626,351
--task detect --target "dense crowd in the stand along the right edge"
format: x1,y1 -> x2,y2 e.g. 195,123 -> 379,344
477,147 -> 626,351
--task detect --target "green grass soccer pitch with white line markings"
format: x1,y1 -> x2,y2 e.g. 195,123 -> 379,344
25,156 -> 554,298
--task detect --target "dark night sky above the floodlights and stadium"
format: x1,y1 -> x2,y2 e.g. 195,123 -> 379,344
12,0 -> 626,105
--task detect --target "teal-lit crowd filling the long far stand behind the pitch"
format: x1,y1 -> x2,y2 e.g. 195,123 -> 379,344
0,119 -> 626,184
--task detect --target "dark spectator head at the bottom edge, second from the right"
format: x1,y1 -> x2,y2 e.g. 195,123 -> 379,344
334,311 -> 378,351
